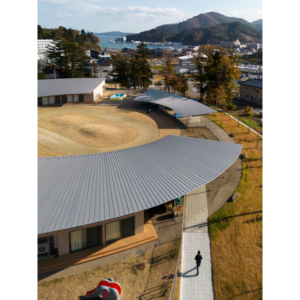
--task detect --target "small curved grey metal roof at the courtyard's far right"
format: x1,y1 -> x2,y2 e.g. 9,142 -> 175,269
133,89 -> 217,117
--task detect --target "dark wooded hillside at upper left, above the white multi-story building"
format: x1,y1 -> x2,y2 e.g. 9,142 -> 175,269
37,25 -> 100,51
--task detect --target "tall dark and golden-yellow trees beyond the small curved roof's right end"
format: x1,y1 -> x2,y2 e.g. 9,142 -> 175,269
191,45 -> 241,106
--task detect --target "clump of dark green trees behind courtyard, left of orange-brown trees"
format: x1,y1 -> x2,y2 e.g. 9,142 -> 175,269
110,43 -> 153,90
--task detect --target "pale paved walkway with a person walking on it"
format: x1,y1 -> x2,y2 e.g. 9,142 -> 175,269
180,186 -> 214,300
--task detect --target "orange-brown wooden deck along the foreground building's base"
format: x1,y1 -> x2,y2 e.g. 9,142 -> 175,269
37,211 -> 158,274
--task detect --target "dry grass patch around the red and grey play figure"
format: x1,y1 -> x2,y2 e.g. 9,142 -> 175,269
37,240 -> 180,300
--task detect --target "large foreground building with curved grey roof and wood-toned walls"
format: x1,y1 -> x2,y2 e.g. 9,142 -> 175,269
37,135 -> 243,264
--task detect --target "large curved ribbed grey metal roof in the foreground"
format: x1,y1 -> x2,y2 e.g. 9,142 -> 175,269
37,135 -> 243,234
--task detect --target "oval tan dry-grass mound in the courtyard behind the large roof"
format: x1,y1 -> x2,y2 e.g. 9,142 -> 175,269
37,112 -> 139,147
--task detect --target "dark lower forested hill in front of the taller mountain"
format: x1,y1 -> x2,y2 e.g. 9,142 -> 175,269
127,22 -> 262,45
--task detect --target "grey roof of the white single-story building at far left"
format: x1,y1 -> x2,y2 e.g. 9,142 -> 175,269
36,78 -> 105,97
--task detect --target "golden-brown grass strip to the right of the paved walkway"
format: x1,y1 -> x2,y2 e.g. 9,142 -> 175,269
209,113 -> 263,300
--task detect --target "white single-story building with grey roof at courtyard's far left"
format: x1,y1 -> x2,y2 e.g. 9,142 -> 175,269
37,78 -> 105,106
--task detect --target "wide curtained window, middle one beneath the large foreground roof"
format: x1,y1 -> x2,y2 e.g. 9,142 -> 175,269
70,226 -> 102,252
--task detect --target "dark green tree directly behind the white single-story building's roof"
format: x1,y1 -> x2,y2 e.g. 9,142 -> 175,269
47,37 -> 89,78
